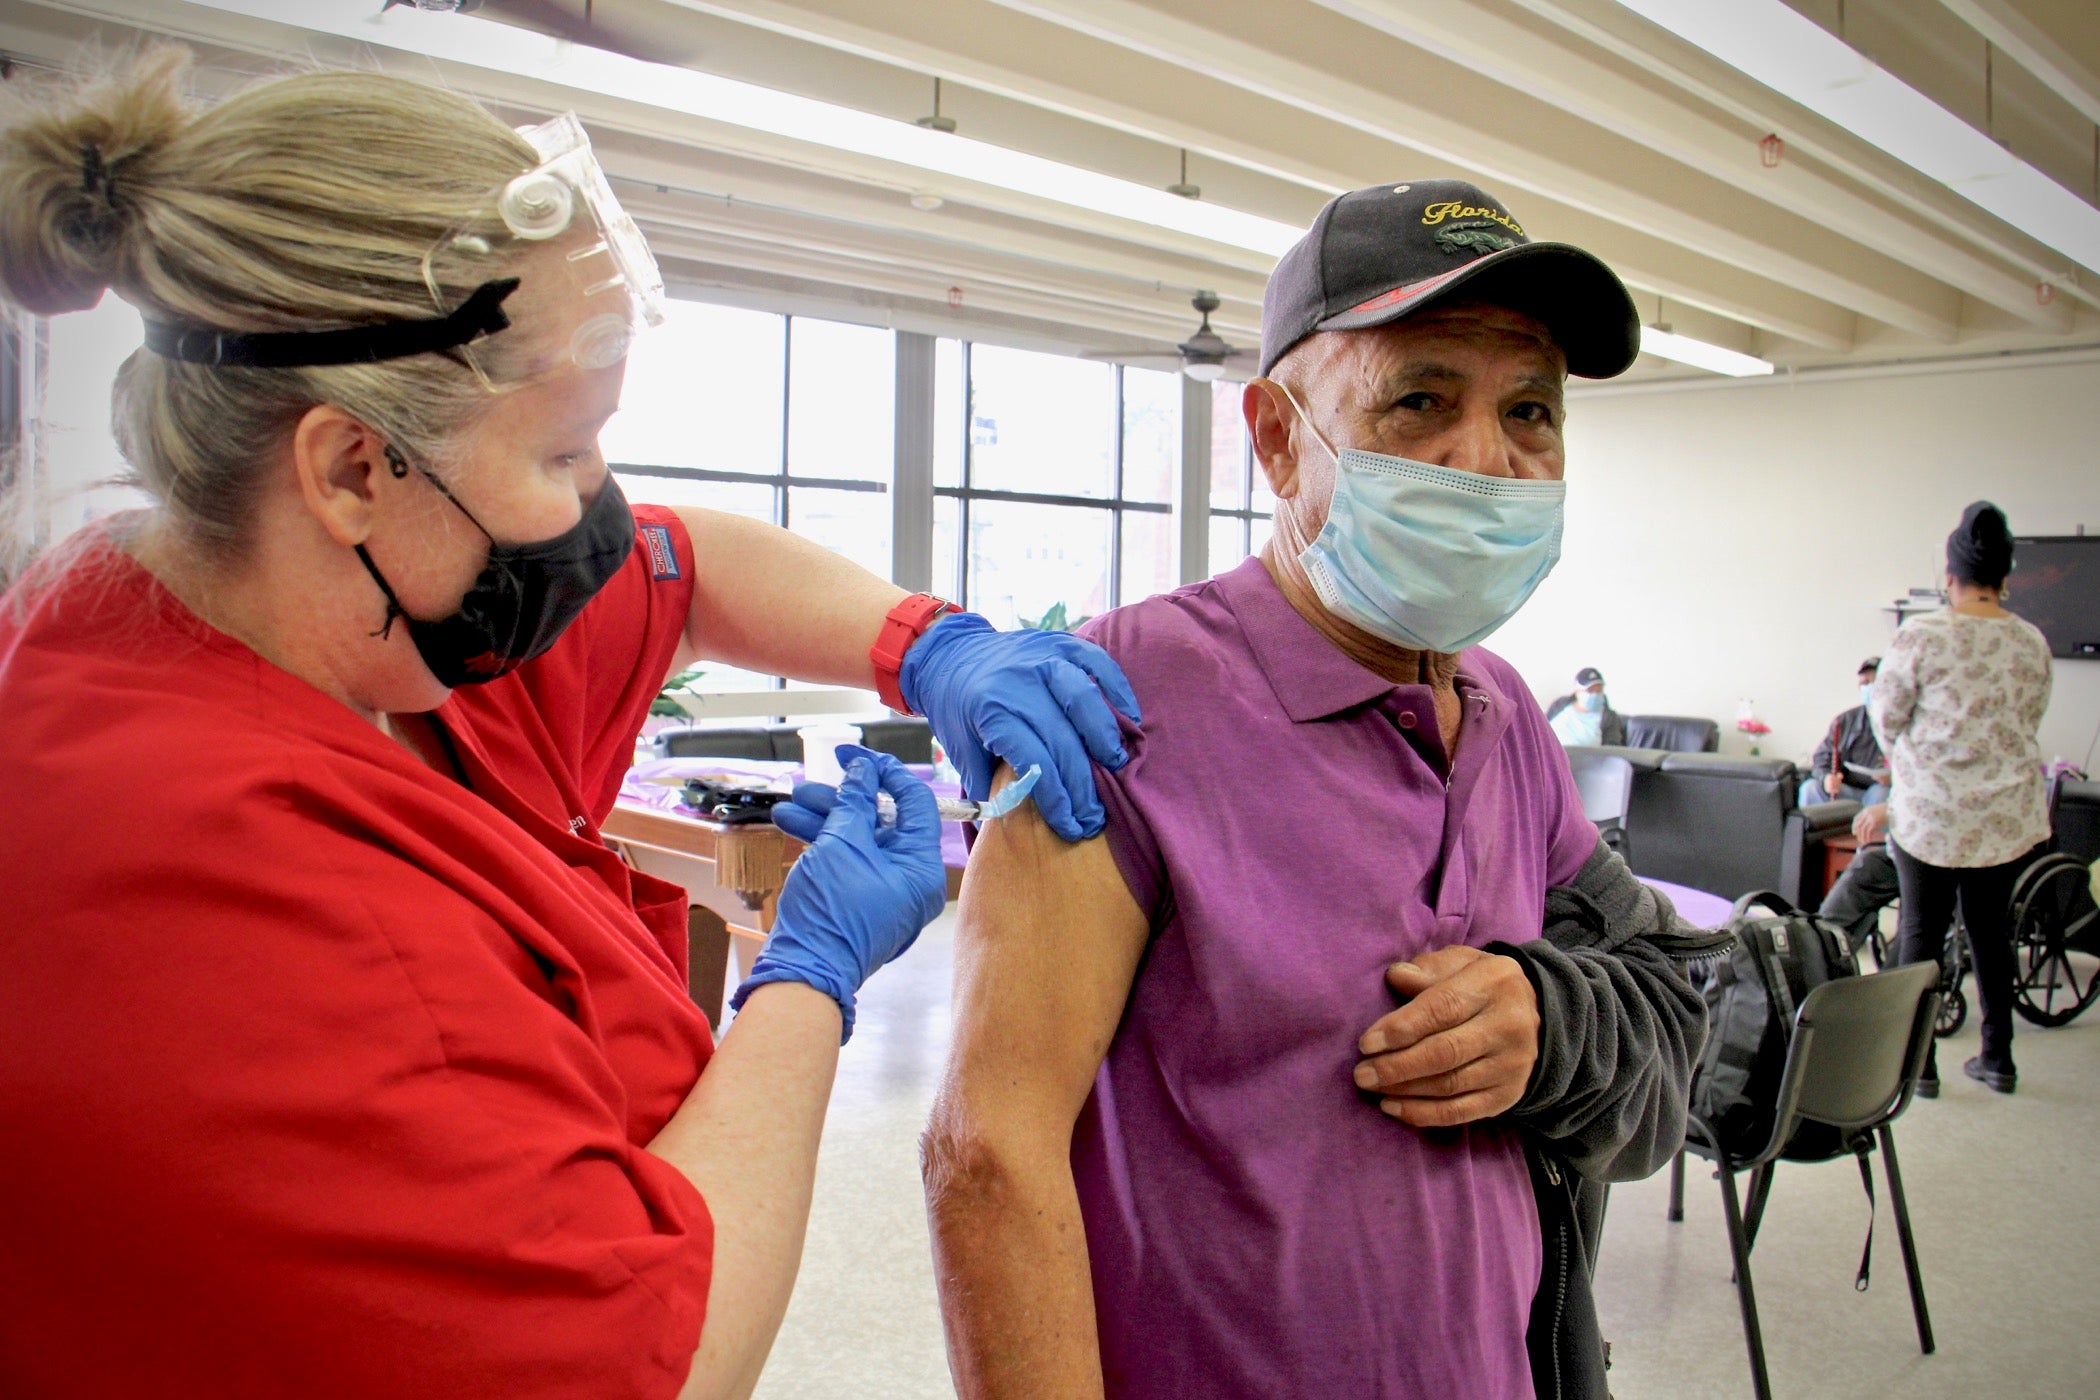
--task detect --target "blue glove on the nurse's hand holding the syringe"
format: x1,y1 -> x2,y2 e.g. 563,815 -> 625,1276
729,743 -> 947,1045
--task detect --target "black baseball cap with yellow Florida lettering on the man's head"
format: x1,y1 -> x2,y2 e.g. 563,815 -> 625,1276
1262,181 -> 1640,380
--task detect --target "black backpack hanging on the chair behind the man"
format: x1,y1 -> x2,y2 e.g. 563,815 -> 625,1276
1693,890 -> 1859,1161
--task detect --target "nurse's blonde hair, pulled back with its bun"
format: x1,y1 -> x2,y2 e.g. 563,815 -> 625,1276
0,46 -> 538,560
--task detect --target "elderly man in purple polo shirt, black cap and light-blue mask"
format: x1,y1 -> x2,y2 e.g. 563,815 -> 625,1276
924,181 -> 1714,1400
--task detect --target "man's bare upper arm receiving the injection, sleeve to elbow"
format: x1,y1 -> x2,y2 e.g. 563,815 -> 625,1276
935,772 -> 1149,1152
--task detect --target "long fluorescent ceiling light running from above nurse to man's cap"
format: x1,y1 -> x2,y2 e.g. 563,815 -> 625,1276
191,0 -> 1304,256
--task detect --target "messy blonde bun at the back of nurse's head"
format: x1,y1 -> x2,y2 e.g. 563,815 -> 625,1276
0,46 -> 193,315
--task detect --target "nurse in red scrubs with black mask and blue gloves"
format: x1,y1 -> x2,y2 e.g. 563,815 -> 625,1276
0,55 -> 1136,1400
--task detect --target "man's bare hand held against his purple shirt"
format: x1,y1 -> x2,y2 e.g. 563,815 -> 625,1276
1357,945 -> 1539,1127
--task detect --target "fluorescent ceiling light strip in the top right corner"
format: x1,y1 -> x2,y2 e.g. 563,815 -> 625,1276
1619,0 -> 2100,273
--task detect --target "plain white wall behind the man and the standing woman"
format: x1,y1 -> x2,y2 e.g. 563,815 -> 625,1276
1489,363 -> 2100,776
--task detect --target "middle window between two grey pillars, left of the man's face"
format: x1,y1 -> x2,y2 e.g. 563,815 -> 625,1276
932,340 -> 1180,628
